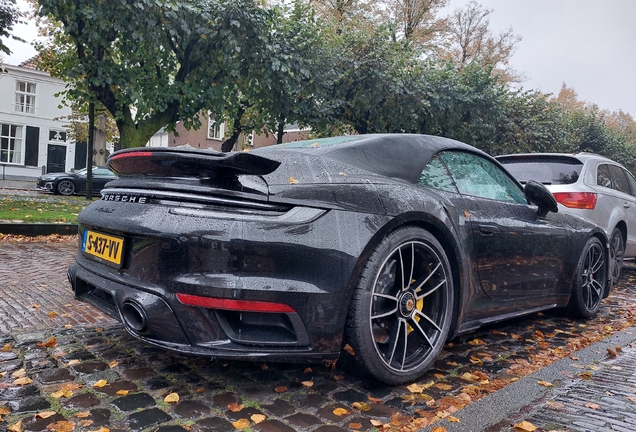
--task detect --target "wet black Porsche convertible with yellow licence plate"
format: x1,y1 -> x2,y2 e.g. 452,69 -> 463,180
69,134 -> 609,384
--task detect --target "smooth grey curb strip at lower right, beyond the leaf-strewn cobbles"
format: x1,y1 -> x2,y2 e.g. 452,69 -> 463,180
424,327 -> 636,432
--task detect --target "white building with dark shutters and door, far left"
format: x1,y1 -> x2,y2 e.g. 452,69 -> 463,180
0,62 -> 76,178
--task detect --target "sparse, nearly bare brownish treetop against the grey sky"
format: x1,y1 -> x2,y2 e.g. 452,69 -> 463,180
439,0 -> 521,81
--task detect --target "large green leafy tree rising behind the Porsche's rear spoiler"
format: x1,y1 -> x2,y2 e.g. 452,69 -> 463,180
37,0 -> 268,148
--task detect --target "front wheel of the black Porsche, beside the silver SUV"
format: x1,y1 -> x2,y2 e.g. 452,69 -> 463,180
568,237 -> 609,318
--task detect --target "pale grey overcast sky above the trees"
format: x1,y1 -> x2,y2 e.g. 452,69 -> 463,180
6,0 -> 636,117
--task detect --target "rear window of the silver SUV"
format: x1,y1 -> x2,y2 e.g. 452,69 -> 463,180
497,156 -> 583,185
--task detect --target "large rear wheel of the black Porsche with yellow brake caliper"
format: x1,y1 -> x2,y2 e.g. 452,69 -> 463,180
345,227 -> 453,385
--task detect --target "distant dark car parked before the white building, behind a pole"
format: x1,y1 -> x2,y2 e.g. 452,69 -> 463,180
35,167 -> 116,195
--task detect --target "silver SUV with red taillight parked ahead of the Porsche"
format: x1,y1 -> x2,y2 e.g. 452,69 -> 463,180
497,153 -> 636,285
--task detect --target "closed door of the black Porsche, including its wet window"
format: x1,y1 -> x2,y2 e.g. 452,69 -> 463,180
439,151 -> 566,307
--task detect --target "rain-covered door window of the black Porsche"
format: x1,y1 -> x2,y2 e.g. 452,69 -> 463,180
440,152 -> 528,204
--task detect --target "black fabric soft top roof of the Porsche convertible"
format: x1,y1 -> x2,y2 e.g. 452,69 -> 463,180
251,134 -> 485,183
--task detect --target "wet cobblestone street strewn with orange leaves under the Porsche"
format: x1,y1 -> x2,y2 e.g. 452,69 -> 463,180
0,241 -> 636,432
